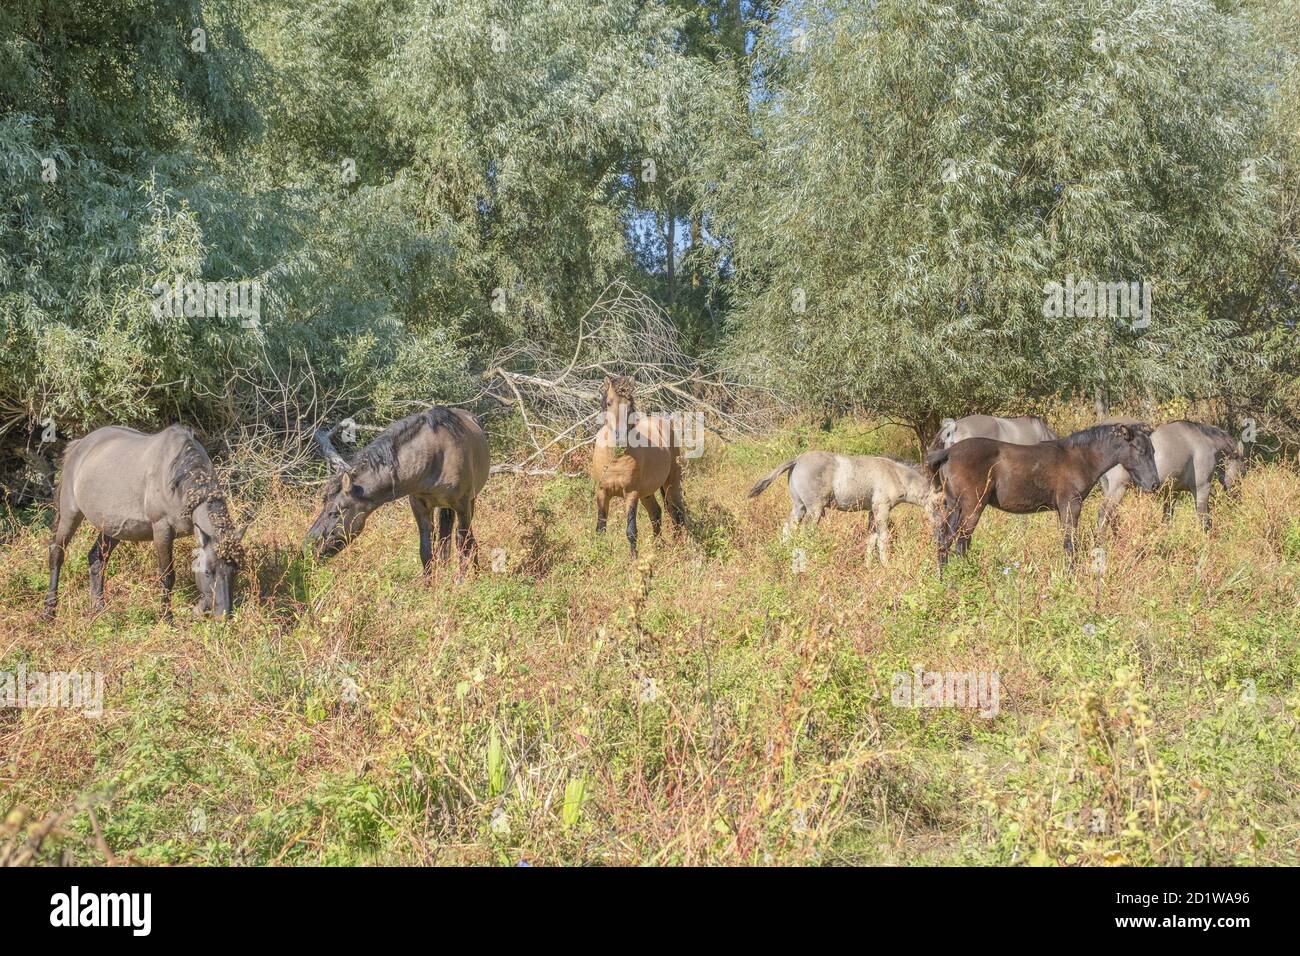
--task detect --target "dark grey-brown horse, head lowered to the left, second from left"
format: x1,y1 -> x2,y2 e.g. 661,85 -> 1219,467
306,405 -> 488,567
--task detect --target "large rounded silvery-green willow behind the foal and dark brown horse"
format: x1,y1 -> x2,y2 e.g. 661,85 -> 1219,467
712,0 -> 1275,436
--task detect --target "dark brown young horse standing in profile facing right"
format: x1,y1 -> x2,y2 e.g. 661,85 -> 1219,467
926,425 -> 1156,567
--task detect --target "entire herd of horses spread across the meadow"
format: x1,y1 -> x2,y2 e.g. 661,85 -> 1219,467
32,376 -> 1244,618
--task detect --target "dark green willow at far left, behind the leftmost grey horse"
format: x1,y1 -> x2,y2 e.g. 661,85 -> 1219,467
0,0 -> 260,434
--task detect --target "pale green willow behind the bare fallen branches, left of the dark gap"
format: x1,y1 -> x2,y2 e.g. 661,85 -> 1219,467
263,0 -> 738,356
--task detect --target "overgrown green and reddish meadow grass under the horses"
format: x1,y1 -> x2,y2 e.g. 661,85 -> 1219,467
0,424 -> 1300,864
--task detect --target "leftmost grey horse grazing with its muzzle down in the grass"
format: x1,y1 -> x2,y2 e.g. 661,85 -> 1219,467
46,425 -> 243,619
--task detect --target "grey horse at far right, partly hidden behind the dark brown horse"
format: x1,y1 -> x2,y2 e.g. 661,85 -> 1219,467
1097,421 -> 1245,531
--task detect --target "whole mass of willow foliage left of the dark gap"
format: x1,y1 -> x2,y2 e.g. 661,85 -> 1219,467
0,0 -> 725,434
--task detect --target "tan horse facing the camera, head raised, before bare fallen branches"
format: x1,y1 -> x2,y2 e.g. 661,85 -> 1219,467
590,376 -> 686,557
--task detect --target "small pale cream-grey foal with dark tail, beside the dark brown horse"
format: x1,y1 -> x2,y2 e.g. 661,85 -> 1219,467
749,451 -> 943,564
